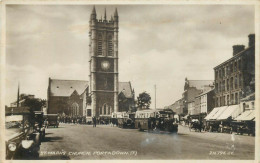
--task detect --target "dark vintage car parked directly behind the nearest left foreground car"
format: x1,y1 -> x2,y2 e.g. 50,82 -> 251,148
34,111 -> 45,140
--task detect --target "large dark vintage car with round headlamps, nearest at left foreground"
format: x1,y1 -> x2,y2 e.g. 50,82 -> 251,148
5,108 -> 40,160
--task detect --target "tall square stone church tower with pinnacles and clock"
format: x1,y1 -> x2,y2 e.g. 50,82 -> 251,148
89,7 -> 119,116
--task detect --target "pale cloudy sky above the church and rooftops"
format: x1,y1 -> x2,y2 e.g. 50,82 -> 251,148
5,5 -> 255,108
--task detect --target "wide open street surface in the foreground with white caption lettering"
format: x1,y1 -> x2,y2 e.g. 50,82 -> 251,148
40,124 -> 255,160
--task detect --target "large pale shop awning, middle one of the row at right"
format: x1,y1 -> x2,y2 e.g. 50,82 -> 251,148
216,105 -> 239,120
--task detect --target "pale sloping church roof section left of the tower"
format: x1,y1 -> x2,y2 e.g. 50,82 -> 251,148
49,79 -> 88,96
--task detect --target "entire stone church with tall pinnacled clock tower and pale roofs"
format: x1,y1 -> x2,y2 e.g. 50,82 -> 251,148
47,7 -> 135,118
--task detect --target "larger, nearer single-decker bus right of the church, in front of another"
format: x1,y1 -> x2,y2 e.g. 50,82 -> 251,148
135,109 -> 178,133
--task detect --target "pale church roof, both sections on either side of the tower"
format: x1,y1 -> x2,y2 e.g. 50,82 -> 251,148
49,79 -> 133,98
